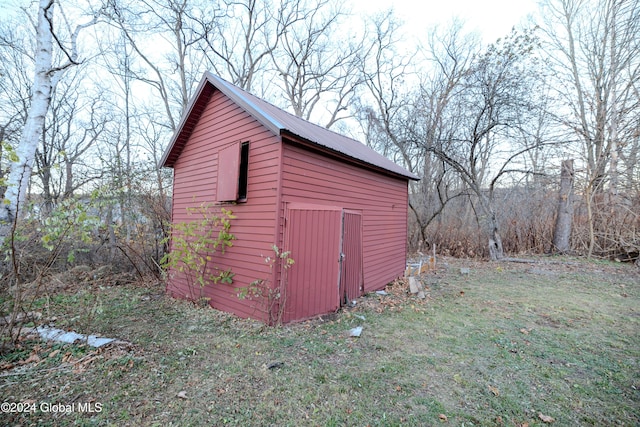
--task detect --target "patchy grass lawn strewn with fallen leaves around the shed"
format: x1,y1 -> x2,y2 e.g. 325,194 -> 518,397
0,258 -> 640,427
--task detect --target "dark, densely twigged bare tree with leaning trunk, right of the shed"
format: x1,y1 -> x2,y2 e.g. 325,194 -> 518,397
426,32 -> 548,260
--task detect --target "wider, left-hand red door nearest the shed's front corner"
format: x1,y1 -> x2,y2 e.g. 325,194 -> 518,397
283,205 -> 342,322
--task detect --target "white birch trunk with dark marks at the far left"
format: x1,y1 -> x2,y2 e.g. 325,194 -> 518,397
0,0 -> 53,231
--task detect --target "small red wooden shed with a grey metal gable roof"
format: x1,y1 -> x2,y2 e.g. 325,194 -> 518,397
161,73 -> 417,322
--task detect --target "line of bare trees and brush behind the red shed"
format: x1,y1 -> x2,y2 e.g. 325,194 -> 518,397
0,0 -> 640,280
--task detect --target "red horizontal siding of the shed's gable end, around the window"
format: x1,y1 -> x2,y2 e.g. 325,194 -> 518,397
168,91 -> 280,317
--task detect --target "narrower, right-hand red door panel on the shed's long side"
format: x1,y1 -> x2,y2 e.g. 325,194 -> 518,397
340,210 -> 363,304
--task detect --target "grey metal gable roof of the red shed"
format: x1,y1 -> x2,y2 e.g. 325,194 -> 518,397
160,72 -> 419,180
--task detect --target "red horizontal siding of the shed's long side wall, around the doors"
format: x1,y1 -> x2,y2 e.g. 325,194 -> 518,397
280,143 -> 408,292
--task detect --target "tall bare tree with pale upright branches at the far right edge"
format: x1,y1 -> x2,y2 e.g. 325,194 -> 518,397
542,0 -> 640,256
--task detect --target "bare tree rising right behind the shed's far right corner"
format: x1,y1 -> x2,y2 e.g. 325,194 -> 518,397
360,12 -> 472,251
